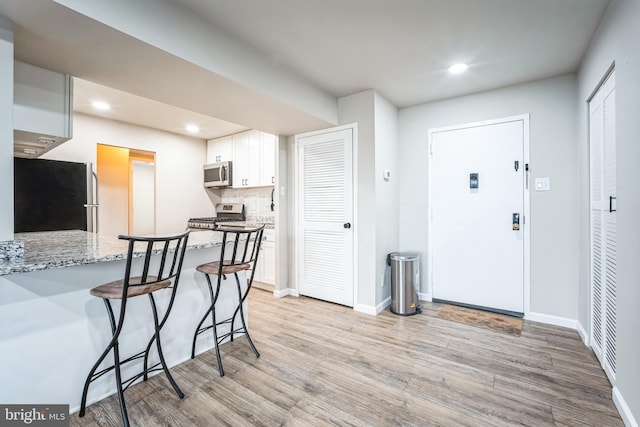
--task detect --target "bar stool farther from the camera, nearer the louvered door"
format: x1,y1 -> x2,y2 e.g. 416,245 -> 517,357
191,225 -> 264,377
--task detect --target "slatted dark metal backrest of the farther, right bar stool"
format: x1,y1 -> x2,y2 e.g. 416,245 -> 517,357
217,225 -> 264,279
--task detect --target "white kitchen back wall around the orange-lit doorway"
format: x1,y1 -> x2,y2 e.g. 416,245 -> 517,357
42,113 -> 213,234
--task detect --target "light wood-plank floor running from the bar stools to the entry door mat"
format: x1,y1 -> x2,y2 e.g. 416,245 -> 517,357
71,289 -> 623,427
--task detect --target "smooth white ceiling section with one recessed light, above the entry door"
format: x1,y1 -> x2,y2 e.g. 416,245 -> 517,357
178,0 -> 609,108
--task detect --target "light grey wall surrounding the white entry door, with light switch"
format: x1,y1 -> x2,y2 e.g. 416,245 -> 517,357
399,75 -> 579,320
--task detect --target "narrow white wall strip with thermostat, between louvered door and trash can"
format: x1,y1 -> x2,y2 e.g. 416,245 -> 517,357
374,93 -> 402,306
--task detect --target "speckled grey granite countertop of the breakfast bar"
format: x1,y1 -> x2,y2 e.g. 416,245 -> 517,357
0,230 -> 222,276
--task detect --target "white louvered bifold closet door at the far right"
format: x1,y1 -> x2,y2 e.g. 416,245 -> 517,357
589,73 -> 616,383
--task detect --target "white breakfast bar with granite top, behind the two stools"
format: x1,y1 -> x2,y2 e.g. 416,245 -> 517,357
0,231 -> 248,413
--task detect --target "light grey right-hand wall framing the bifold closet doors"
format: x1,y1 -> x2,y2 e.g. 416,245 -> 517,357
577,0 -> 640,426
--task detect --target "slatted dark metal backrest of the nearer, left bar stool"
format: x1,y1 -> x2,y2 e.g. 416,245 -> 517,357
118,231 -> 189,298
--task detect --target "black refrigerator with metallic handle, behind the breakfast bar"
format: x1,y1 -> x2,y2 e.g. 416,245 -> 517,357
14,157 -> 97,233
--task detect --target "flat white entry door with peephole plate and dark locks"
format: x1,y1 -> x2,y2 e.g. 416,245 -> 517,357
429,116 -> 528,314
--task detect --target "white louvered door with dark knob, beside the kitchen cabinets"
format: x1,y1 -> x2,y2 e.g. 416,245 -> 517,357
296,127 -> 355,307
